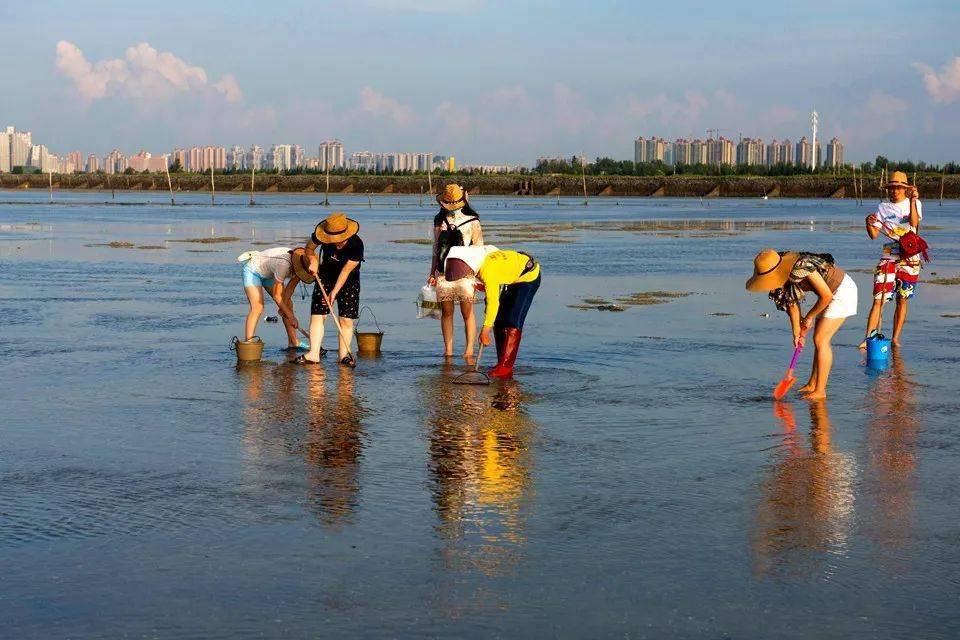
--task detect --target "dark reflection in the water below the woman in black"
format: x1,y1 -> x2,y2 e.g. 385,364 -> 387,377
303,367 -> 363,524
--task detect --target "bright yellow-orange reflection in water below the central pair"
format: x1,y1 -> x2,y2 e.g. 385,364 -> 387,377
423,366 -> 536,575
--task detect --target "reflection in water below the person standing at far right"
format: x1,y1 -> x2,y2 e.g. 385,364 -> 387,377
865,350 -> 919,546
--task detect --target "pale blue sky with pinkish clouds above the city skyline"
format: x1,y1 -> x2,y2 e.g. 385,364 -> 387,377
0,0 -> 960,165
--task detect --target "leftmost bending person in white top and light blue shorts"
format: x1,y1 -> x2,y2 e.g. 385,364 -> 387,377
237,247 -> 307,351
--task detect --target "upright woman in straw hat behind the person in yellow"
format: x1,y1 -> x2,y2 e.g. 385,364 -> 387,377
427,184 -> 483,358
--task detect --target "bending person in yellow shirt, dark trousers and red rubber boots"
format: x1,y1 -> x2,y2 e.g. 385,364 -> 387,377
443,245 -> 540,378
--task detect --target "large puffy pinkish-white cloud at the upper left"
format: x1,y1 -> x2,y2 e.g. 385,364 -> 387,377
57,40 -> 243,102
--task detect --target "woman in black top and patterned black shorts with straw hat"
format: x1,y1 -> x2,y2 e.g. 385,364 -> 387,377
294,212 -> 363,367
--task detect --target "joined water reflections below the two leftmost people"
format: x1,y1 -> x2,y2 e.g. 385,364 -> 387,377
238,364 -> 365,525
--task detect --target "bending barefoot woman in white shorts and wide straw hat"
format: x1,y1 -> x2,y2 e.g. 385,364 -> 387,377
747,249 -> 857,400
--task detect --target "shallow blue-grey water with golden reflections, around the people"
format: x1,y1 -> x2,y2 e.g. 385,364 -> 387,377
0,192 -> 960,638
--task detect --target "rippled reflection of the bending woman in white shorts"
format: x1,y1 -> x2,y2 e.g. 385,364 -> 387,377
753,402 -> 854,575
